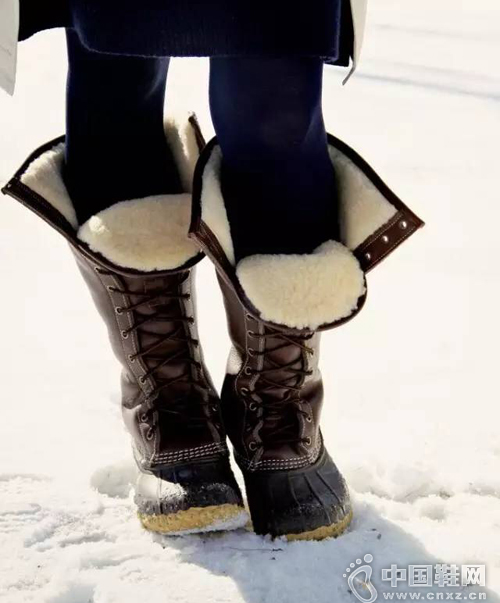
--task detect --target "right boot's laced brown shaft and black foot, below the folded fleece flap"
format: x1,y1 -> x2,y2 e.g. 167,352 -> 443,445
221,281 -> 352,539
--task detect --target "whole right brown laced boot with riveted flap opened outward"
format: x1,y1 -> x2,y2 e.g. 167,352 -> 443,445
191,136 -> 423,539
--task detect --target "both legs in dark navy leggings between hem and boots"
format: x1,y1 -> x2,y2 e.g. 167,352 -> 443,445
65,30 -> 335,259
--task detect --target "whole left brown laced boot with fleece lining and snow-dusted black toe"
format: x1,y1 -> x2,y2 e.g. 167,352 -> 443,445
4,118 -> 248,533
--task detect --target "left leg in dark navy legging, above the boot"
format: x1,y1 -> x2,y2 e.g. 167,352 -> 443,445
64,30 -> 181,223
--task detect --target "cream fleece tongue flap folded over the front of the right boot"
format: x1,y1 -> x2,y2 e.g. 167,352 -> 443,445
236,241 -> 365,329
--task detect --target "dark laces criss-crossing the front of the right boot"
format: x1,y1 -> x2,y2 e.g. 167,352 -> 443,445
242,329 -> 314,448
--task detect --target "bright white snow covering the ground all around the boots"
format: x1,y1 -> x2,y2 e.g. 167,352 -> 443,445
0,0 -> 500,603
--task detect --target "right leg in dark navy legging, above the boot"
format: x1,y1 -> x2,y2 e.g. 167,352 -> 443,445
210,58 -> 337,260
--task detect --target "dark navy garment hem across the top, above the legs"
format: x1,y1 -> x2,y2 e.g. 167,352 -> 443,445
20,0 -> 353,65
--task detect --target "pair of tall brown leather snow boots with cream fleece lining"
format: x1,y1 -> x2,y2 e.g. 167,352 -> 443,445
4,116 -> 423,539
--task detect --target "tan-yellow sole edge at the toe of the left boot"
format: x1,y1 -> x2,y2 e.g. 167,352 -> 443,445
138,504 -> 248,535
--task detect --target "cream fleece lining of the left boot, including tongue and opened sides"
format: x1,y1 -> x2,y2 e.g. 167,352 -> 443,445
21,116 -> 199,272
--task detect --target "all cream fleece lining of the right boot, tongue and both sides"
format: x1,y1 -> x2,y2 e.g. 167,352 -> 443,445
197,139 -> 397,329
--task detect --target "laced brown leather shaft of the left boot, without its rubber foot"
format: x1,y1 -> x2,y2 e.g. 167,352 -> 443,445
74,251 -> 225,466
